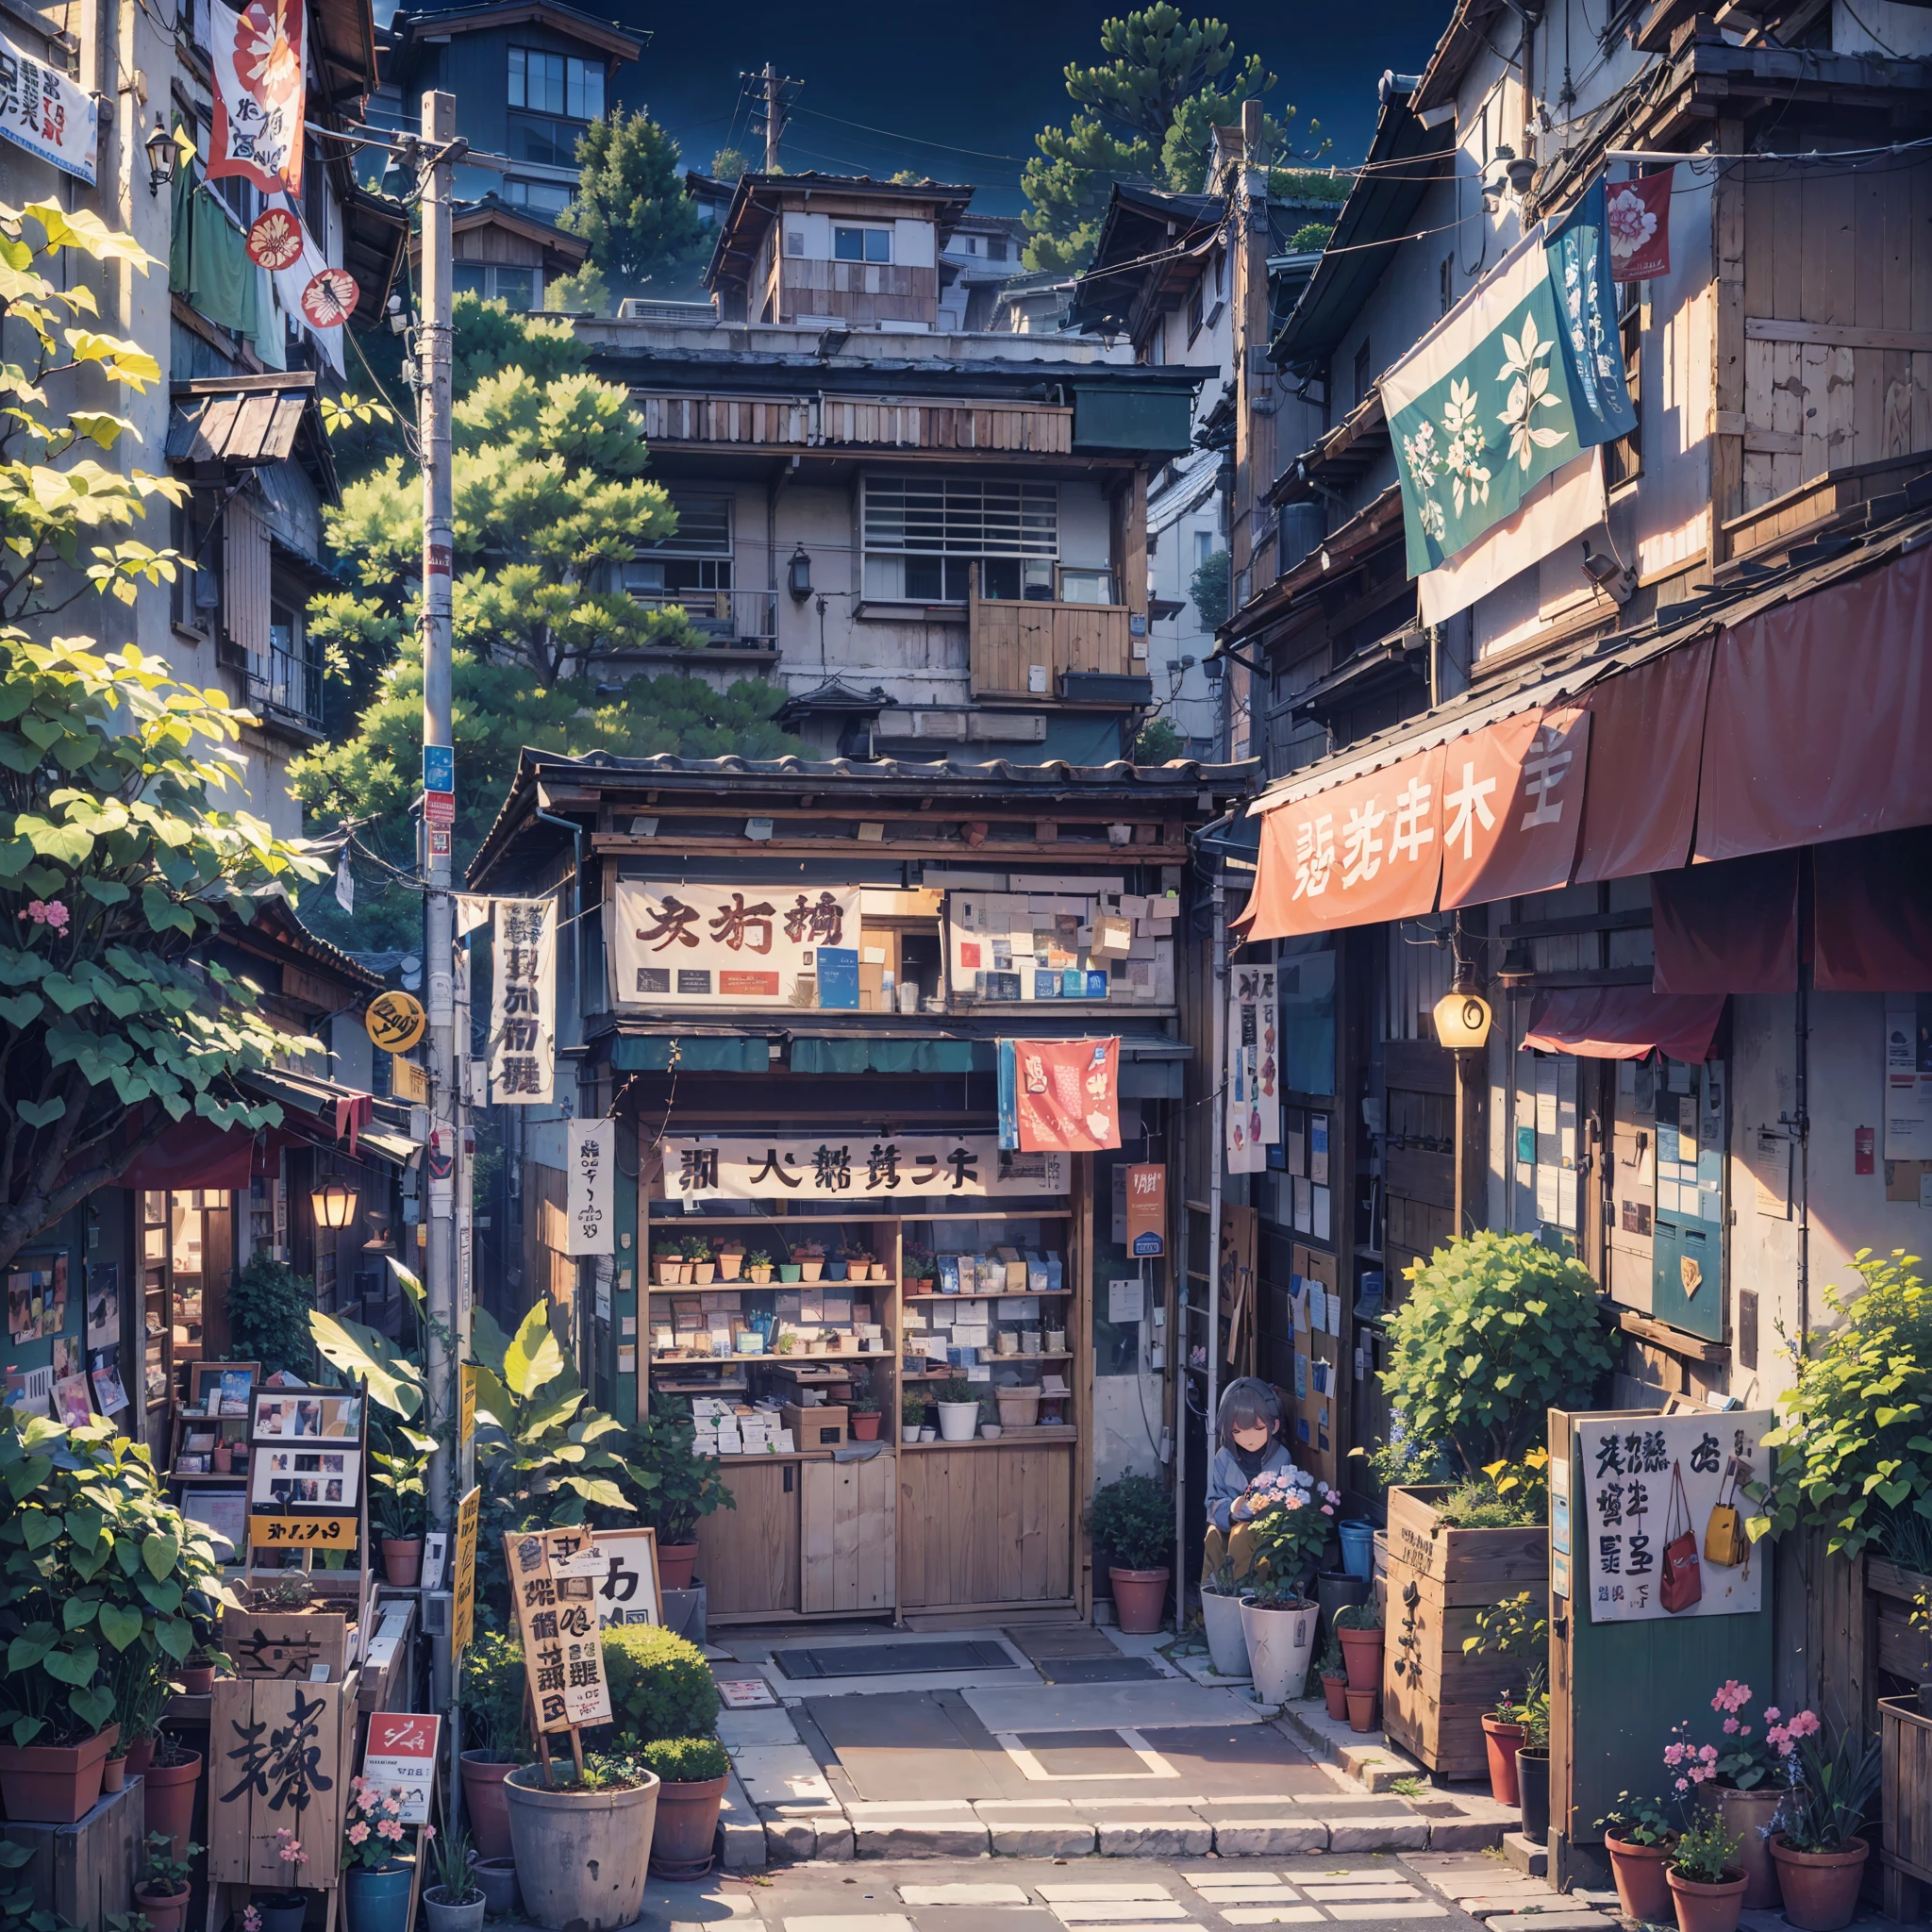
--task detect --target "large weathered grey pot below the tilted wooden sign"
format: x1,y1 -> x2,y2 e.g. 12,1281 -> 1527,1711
507,1754 -> 660,1932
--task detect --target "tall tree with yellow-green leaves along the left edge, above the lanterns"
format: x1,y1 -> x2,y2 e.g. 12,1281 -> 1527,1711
0,203 -> 323,1265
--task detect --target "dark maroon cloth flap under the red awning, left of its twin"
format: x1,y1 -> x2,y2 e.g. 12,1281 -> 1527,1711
1650,852 -> 1799,993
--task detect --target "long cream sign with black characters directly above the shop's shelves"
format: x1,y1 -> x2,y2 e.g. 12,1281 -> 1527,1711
655,1128 -> 1073,1202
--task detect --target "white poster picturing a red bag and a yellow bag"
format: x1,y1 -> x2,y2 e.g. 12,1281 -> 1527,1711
1573,1410 -> 1772,1623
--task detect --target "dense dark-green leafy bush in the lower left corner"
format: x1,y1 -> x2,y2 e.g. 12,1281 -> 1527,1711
0,1408 -> 234,1744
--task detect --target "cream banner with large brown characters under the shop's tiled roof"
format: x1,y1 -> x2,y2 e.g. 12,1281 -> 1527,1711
610,879 -> 859,1008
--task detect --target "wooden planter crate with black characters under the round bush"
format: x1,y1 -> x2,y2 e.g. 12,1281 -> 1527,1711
1381,1488 -> 1549,1777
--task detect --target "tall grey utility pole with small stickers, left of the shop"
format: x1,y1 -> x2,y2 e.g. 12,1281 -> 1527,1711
417,92 -> 458,1530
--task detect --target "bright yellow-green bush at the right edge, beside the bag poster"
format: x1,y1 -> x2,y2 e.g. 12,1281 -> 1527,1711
1746,1248 -> 1932,1557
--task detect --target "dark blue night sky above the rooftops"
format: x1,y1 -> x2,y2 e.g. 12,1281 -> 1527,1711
610,0 -> 1451,212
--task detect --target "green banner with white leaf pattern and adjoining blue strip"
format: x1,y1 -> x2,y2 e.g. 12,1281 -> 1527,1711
1381,182 -> 1637,577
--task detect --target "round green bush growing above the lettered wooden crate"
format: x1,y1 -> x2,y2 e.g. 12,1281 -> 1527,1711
1381,1231 -> 1615,1476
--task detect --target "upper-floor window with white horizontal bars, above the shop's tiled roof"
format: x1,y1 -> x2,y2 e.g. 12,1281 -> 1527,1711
861,477 -> 1060,603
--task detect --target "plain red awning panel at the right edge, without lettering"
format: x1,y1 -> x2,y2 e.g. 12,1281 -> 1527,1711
1696,549 -> 1932,859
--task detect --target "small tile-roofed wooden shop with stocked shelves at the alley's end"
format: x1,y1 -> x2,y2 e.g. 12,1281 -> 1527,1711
470,752 -> 1246,1621
